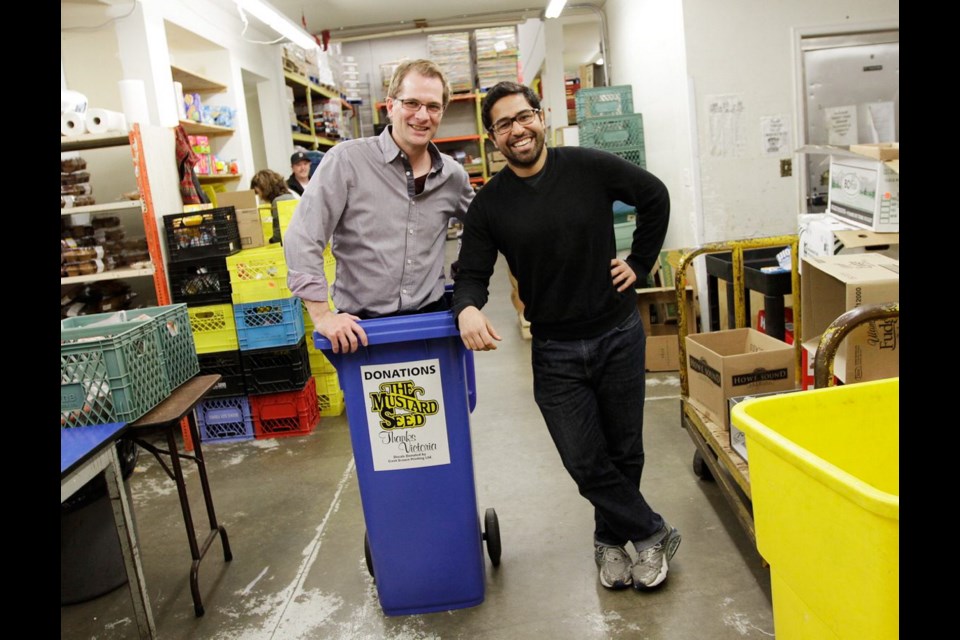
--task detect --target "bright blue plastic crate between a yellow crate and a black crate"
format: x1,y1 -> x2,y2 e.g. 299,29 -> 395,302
233,298 -> 305,351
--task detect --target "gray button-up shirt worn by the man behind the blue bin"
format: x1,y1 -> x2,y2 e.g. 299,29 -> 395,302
283,127 -> 473,317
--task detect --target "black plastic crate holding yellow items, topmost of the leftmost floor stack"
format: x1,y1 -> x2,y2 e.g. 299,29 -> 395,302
163,207 -> 241,262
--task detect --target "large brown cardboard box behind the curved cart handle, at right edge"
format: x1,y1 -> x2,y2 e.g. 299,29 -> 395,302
800,253 -> 900,384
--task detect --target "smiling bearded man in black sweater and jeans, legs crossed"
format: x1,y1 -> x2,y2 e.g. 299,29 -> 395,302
453,82 -> 680,590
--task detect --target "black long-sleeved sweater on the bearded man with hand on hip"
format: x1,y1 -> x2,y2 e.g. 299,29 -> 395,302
453,147 -> 670,340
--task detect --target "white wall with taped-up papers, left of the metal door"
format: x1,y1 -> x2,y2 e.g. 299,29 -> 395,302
604,0 -> 899,246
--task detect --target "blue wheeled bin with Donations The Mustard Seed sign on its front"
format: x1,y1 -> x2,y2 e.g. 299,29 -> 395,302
313,311 -> 500,615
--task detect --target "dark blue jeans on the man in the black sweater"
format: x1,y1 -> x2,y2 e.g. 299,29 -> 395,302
532,310 -> 663,545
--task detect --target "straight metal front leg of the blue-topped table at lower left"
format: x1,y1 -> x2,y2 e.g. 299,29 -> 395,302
104,445 -> 157,638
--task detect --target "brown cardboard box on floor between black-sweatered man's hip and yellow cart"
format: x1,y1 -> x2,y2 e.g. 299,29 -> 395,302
637,287 -> 696,371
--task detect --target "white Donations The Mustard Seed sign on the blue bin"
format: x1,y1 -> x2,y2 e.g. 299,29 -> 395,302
360,359 -> 450,471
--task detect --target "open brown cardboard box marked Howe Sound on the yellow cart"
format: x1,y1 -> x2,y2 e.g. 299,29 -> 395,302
686,328 -> 796,428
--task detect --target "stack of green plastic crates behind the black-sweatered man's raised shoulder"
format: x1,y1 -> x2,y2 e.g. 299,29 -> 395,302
575,84 -> 647,250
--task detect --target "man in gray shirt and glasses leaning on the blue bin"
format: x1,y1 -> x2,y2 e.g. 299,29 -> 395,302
283,60 -> 473,353
